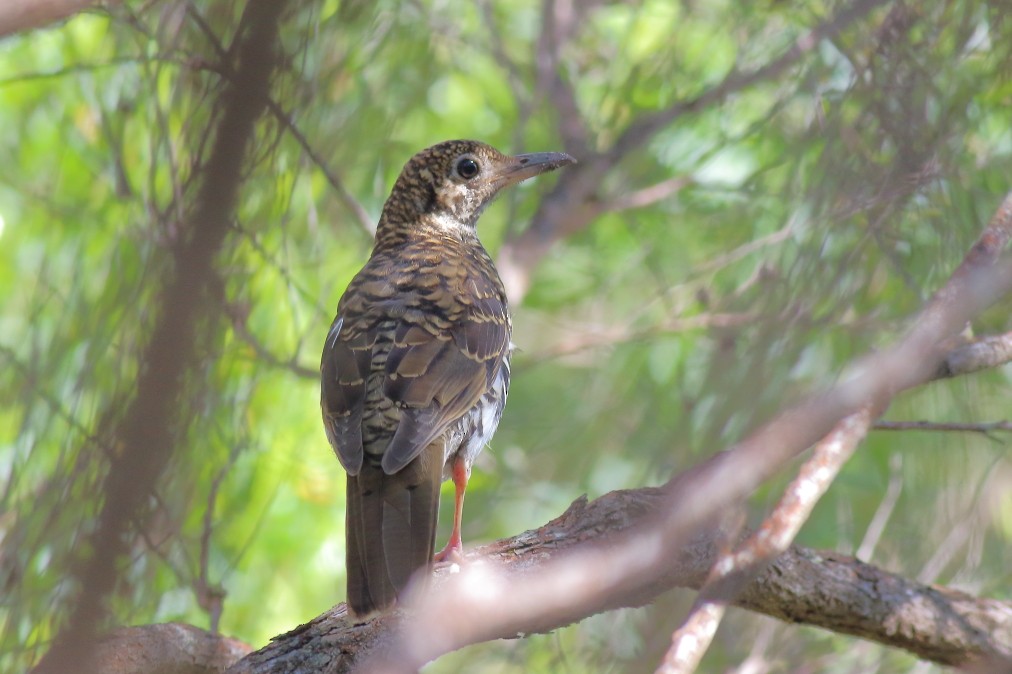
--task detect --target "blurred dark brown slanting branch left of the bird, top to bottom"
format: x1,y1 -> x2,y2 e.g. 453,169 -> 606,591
35,2 -> 284,674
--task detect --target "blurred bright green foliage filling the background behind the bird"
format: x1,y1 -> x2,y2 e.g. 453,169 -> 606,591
0,0 -> 1012,672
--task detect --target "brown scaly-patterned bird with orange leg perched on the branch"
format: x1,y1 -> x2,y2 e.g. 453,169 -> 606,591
320,140 -> 576,618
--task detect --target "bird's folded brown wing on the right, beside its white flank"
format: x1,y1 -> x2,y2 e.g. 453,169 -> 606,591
383,287 -> 510,475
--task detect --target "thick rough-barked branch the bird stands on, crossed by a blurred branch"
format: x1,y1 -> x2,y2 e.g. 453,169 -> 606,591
228,489 -> 1012,674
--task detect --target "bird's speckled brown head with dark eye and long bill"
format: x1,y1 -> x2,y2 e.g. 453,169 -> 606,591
377,141 -> 576,236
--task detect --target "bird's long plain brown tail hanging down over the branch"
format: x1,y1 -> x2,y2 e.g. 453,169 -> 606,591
345,441 -> 443,617
